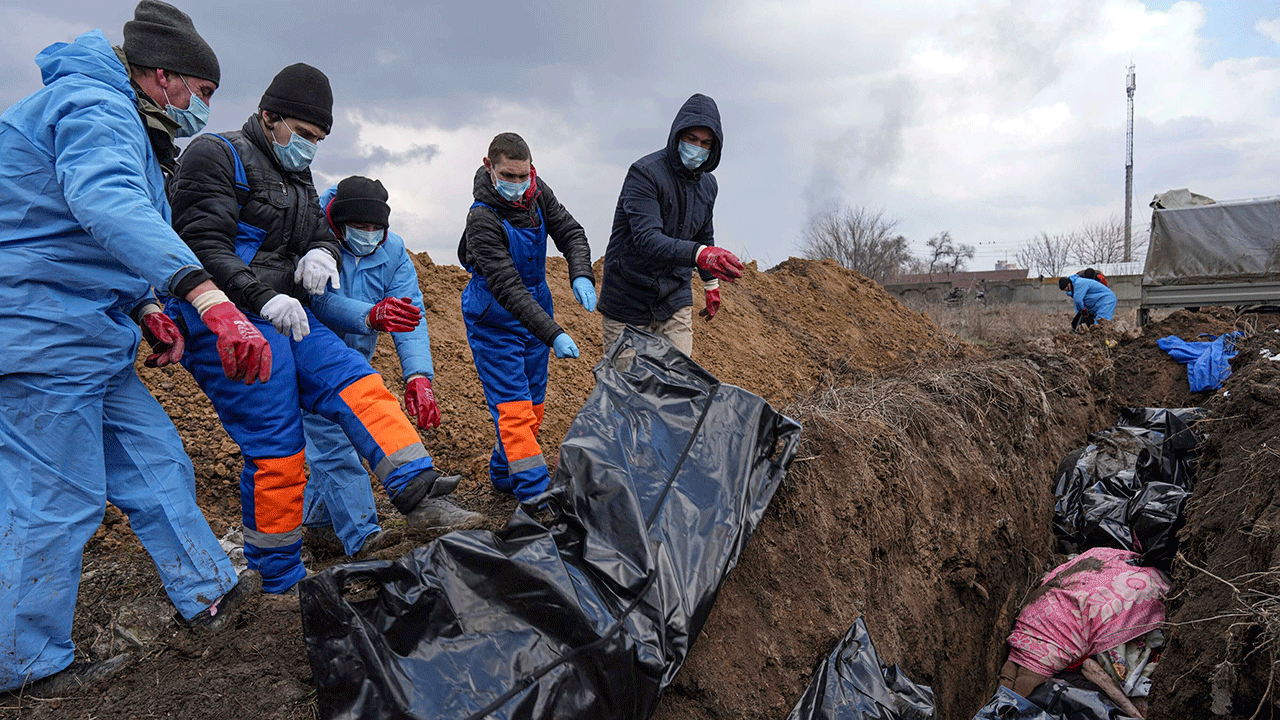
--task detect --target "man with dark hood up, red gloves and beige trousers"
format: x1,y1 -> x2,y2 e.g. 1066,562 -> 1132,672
599,95 -> 742,355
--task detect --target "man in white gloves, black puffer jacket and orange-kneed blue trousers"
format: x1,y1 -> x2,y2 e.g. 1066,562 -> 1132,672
166,63 -> 480,593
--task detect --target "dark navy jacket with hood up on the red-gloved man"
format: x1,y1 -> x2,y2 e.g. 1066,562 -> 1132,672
596,95 -> 724,325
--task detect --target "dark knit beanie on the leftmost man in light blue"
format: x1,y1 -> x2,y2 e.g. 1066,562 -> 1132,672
124,0 -> 223,83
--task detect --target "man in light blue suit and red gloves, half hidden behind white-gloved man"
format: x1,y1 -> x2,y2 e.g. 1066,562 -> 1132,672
302,176 -> 465,557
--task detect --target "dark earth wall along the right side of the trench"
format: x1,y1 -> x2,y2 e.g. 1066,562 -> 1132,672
1151,326 -> 1280,720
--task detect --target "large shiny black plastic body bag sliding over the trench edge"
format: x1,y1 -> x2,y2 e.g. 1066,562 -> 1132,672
300,328 -> 800,720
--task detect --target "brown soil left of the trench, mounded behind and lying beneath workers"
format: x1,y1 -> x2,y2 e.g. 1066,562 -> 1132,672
0,255 -> 1280,720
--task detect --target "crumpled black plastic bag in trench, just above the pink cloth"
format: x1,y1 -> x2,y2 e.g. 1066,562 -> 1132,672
1053,407 -> 1204,558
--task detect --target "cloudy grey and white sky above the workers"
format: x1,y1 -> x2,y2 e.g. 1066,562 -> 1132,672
0,0 -> 1280,269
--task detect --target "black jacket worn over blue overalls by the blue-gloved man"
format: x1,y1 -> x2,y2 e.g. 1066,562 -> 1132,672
458,165 -> 595,347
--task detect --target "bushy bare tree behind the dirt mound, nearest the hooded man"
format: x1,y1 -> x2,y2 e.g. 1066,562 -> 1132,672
800,205 -> 911,282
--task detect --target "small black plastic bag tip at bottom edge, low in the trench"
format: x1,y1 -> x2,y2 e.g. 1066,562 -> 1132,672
787,618 -> 933,720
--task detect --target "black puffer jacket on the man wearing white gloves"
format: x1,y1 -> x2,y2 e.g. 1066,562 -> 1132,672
169,114 -> 342,315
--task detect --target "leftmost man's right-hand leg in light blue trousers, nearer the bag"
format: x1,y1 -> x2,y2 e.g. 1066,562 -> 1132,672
102,368 -> 237,619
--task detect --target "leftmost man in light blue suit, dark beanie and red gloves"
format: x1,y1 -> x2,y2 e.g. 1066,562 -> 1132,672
0,0 -> 270,694
